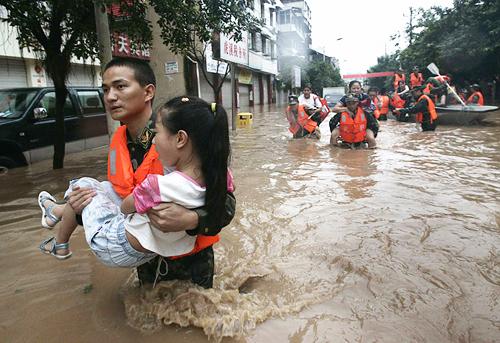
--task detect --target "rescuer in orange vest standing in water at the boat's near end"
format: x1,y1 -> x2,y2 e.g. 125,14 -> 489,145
396,86 -> 438,131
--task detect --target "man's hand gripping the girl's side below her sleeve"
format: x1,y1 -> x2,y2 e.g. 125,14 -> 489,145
147,202 -> 198,232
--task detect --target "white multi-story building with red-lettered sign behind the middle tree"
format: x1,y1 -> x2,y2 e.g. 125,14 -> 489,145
199,0 -> 282,111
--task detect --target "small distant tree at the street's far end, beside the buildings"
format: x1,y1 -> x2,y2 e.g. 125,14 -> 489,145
302,61 -> 344,94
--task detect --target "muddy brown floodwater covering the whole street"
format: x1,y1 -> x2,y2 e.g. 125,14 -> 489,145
0,106 -> 500,343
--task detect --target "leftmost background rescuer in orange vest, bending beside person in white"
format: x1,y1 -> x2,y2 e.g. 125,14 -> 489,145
286,95 -> 321,139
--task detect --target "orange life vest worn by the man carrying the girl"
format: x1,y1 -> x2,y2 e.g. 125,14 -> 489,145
108,125 -> 219,259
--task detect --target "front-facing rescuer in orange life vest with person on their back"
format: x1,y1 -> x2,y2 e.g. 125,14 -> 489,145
330,94 -> 377,149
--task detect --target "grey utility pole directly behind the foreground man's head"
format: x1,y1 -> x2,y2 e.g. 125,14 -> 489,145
94,0 -> 120,139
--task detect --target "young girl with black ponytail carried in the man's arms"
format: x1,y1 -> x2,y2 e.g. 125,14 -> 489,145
40,96 -> 233,267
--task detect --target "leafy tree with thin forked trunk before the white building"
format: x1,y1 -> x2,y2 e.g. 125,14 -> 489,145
150,0 -> 260,100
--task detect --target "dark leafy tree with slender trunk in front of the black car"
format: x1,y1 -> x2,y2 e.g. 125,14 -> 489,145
0,0 -> 151,169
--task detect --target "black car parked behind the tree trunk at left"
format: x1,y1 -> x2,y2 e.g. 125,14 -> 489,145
0,87 -> 108,170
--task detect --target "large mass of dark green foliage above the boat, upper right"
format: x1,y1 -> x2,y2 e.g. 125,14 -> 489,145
376,0 -> 500,86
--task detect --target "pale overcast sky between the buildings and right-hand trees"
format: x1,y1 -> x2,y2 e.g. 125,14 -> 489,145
309,0 -> 453,74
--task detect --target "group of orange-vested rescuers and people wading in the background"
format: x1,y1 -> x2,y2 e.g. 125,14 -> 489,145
286,67 -> 484,148
